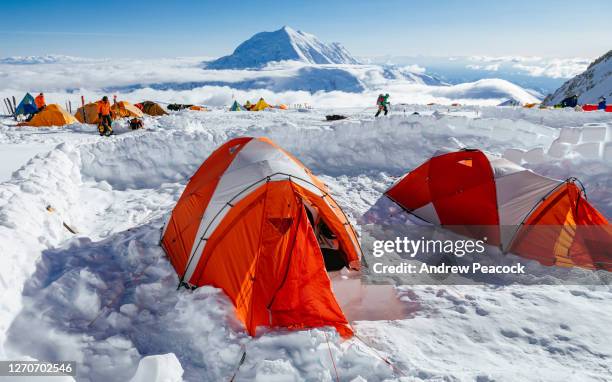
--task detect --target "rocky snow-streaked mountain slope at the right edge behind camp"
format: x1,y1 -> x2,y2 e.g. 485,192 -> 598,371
544,50 -> 612,105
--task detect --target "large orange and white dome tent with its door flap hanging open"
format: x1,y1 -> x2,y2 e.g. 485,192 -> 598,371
161,138 -> 361,336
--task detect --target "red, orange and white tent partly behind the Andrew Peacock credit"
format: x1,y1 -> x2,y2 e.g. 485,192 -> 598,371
385,150 -> 612,271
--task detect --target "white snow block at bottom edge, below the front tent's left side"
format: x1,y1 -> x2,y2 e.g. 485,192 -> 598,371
130,353 -> 183,382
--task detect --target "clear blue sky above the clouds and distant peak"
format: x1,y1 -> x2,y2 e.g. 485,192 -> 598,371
0,0 -> 612,58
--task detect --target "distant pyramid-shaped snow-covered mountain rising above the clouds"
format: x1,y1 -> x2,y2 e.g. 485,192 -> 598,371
207,26 -> 358,69
